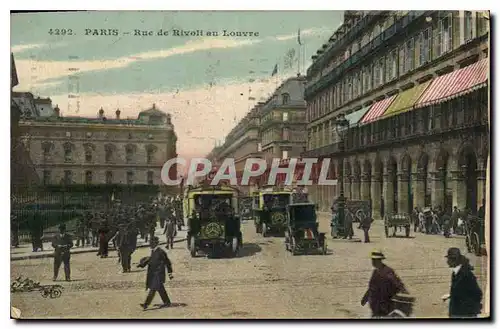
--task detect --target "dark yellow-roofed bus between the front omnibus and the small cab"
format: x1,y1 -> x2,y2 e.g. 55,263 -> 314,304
253,190 -> 292,236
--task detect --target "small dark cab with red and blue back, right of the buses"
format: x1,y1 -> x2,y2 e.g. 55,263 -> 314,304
285,202 -> 326,255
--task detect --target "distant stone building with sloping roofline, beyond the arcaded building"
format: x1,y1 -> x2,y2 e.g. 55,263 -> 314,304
208,76 -> 307,193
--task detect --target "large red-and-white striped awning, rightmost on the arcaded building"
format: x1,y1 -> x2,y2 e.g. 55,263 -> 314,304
415,58 -> 489,108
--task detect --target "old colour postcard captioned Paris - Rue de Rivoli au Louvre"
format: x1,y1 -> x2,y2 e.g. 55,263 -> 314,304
10,10 -> 491,320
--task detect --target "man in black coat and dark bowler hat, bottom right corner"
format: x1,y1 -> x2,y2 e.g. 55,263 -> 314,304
443,248 -> 483,318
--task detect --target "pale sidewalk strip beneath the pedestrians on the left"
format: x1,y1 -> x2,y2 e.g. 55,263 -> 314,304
10,226 -> 186,261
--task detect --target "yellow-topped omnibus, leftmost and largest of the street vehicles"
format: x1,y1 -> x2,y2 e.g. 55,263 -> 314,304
183,186 -> 243,257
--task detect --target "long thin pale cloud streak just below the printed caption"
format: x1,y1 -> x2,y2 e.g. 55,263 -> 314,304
12,38 -> 262,90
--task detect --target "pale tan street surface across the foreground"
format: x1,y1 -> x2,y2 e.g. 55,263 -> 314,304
11,216 -> 486,319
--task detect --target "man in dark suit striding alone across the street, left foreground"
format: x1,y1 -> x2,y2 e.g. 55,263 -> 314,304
138,236 -> 174,310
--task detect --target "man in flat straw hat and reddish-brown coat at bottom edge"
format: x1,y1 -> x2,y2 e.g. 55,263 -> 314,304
361,249 -> 408,318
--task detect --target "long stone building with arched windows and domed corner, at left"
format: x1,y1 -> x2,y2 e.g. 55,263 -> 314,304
20,104 -> 177,185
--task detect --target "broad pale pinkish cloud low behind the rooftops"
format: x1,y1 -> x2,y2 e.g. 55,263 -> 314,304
50,79 -> 292,158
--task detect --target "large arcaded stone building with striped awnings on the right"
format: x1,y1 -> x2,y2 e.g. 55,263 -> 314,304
304,11 -> 490,218
